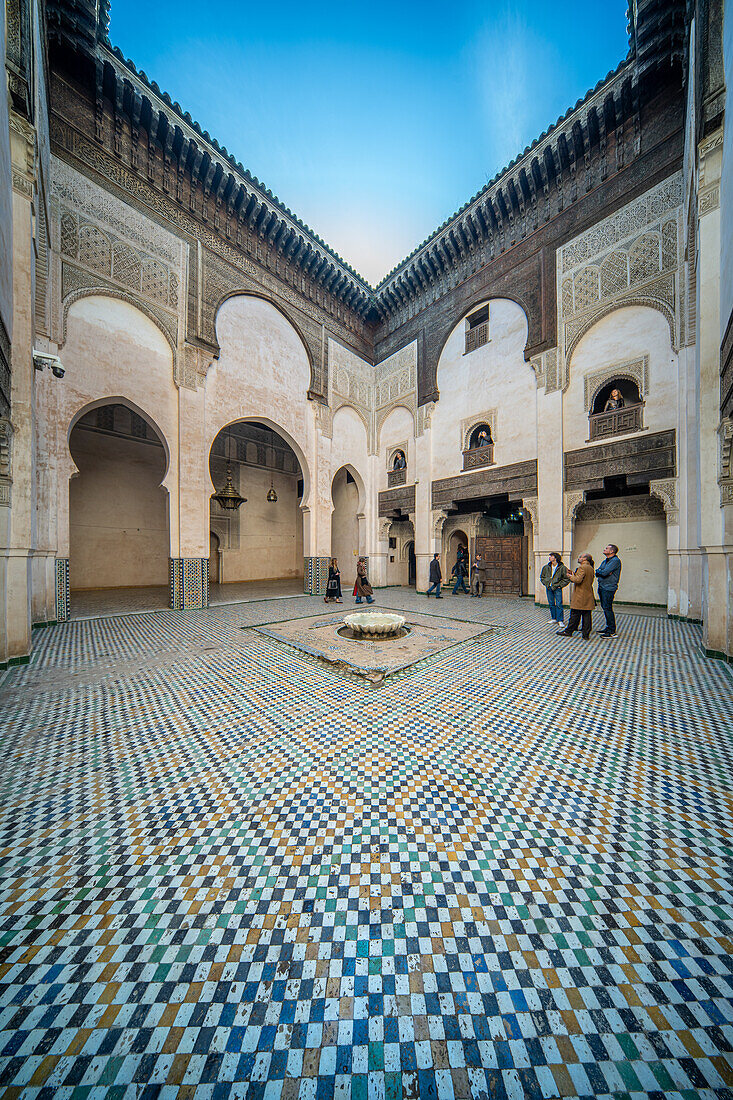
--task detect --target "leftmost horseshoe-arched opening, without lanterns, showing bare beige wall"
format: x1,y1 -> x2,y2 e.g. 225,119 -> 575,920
68,402 -> 169,606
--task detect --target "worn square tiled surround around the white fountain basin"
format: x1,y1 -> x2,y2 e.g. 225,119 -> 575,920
253,606 -> 496,681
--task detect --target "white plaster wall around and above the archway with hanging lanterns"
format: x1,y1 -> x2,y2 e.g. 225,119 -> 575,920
203,295 -> 314,550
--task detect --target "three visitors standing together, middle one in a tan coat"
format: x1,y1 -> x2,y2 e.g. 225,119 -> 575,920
539,542 -> 621,640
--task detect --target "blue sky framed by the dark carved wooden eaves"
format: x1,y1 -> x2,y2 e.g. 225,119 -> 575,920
110,0 -> 627,283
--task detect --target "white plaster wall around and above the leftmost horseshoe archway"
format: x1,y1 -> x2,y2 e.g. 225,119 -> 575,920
58,295 -> 178,558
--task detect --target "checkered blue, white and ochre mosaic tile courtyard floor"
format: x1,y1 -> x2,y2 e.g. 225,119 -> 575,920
0,590 -> 733,1100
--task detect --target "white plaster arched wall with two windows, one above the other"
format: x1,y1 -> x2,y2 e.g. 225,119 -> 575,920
431,298 -> 537,477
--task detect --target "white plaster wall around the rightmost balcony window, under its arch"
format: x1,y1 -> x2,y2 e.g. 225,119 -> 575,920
562,306 -> 678,450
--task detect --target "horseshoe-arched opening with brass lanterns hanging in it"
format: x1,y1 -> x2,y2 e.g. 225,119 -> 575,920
209,420 -> 304,585
